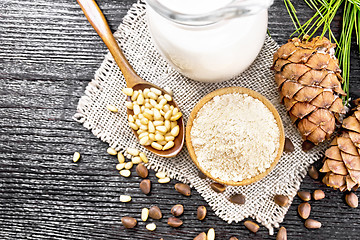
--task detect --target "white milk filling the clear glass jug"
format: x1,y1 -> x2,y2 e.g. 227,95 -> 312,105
147,0 -> 268,82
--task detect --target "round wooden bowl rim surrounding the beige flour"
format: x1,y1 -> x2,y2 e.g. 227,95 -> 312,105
185,87 -> 285,186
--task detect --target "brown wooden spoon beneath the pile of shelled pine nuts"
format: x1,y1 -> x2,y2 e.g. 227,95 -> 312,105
77,0 -> 185,158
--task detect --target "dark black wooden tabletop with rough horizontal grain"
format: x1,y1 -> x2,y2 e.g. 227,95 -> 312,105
0,0 -> 360,240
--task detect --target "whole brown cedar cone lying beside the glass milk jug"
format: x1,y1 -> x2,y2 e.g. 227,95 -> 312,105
272,37 -> 346,144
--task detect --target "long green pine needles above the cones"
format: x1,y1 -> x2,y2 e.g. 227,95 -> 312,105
284,0 -> 360,102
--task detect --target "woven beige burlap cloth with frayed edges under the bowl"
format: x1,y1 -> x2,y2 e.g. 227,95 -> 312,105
74,1 -> 322,234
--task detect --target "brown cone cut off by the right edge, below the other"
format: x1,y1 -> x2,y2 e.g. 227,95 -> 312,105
320,105 -> 360,191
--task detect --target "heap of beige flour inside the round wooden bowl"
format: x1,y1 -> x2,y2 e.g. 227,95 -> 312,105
191,93 -> 280,181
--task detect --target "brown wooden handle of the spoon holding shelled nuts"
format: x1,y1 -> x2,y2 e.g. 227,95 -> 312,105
77,0 -> 145,87
